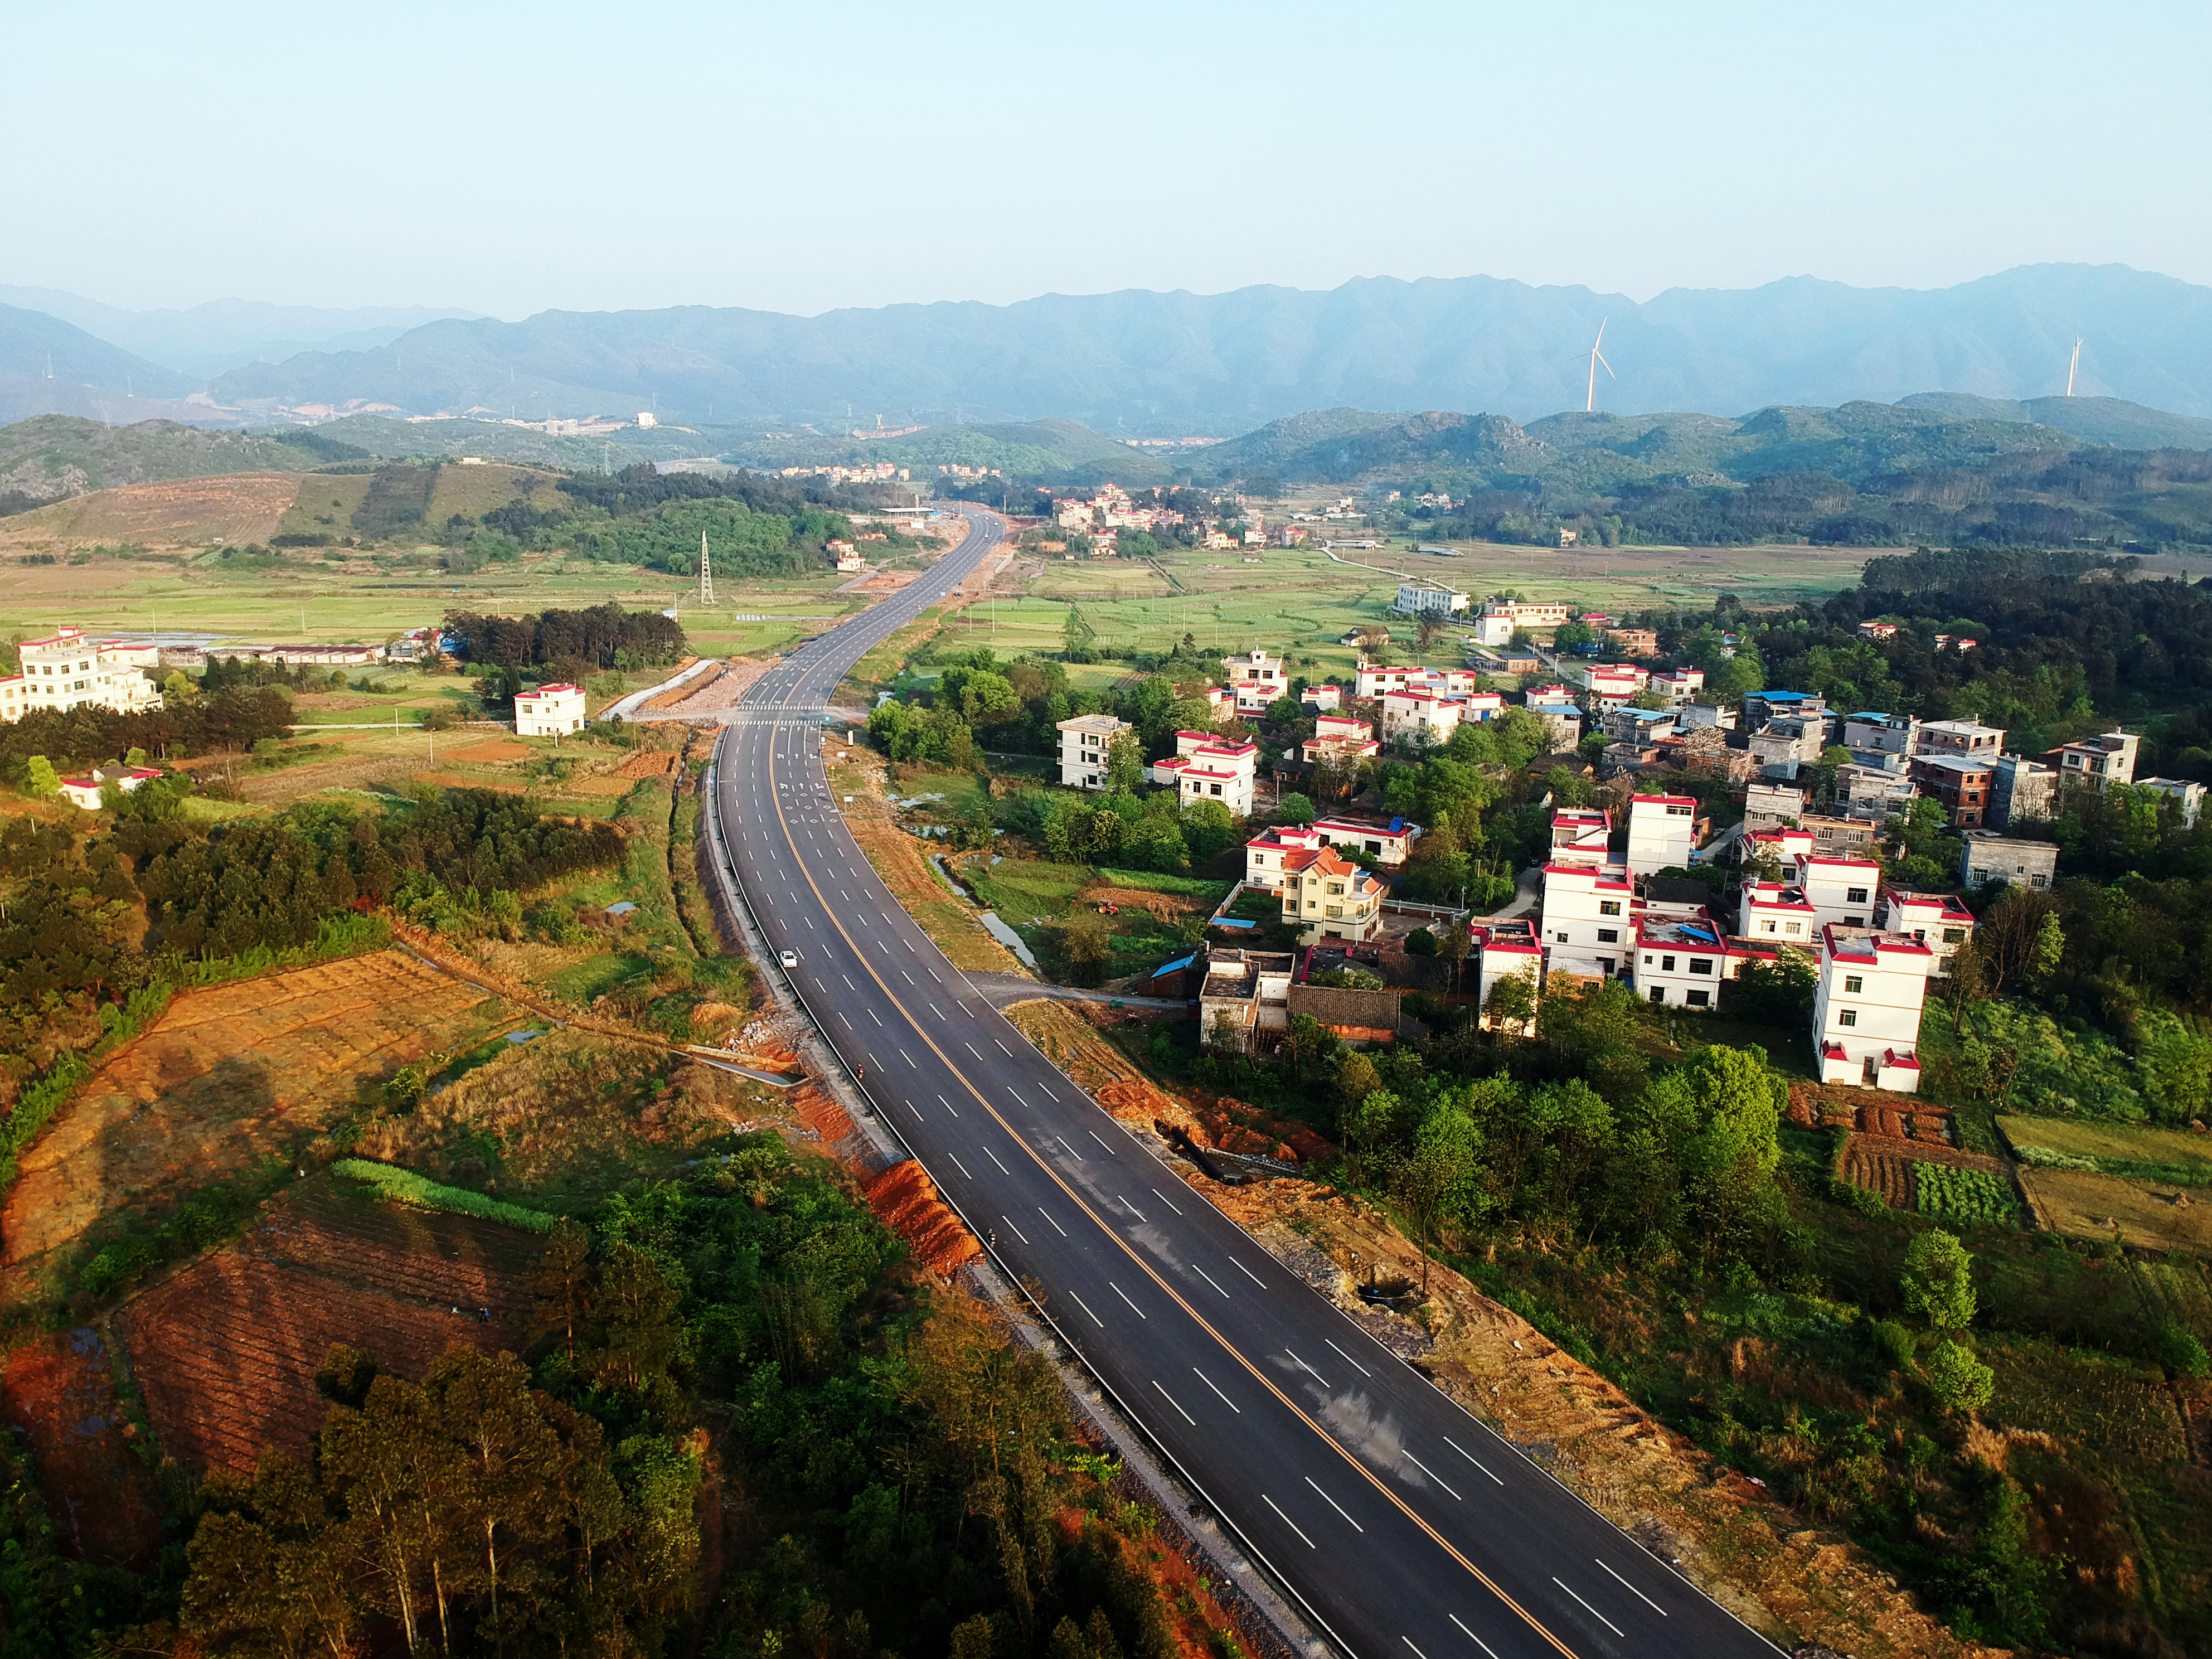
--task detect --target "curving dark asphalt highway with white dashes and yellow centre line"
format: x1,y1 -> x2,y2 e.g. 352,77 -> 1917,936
710,509 -> 1776,1659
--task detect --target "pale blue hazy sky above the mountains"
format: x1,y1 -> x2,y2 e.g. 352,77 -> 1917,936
0,0 -> 2212,316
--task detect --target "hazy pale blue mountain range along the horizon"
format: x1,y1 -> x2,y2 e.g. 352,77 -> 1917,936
0,265 -> 2212,436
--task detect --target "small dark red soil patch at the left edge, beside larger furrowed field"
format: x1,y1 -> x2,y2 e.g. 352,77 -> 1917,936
0,1327 -> 162,1570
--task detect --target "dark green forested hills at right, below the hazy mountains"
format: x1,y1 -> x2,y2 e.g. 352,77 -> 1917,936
1195,400 -> 2212,549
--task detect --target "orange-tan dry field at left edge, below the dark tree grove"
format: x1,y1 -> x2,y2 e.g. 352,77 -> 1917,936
0,951 -> 500,1270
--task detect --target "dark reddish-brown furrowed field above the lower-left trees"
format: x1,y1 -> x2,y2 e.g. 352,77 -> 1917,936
117,1179 -> 540,1473
